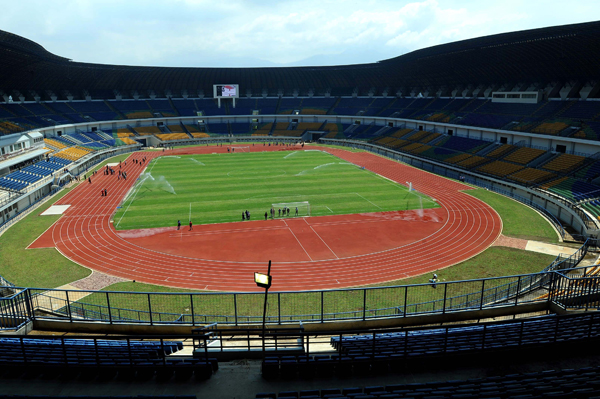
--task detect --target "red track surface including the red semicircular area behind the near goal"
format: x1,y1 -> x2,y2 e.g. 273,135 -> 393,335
30,146 -> 502,291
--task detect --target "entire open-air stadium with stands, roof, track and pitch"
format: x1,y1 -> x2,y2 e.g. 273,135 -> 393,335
0,18 -> 600,398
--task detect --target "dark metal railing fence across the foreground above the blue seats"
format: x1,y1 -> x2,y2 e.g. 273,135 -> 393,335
0,240 -> 600,329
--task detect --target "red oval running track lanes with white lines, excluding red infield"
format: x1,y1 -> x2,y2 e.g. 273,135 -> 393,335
31,146 -> 502,291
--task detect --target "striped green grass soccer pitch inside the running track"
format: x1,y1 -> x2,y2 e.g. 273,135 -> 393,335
114,151 -> 438,230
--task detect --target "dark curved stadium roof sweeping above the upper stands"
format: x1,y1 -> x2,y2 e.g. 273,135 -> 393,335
0,21 -> 600,100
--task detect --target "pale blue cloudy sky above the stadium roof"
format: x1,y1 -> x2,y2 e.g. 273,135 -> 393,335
0,0 -> 600,67
